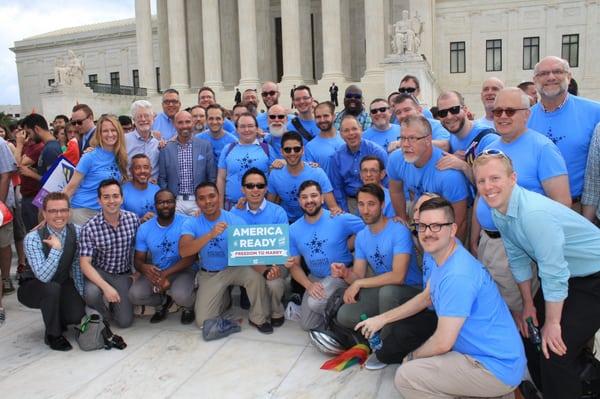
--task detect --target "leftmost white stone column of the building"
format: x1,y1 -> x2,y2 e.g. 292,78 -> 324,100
135,0 -> 156,95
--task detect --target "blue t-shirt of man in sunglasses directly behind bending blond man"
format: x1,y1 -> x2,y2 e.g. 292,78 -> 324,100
477,129 -> 567,231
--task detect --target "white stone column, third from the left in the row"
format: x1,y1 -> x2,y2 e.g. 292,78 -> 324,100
202,0 -> 223,90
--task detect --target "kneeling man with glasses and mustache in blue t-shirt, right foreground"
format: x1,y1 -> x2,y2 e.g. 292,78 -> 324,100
356,198 -> 525,399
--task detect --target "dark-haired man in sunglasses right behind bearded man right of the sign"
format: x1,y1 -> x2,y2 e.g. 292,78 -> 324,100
267,132 -> 343,223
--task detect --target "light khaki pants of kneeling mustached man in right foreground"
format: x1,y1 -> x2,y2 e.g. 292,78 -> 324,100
394,352 -> 516,399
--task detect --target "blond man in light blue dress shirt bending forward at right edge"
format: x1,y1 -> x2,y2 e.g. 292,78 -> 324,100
473,151 -> 600,399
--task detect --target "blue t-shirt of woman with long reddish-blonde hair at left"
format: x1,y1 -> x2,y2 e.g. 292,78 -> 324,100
71,147 -> 121,210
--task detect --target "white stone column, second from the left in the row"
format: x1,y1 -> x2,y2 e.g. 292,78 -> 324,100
167,0 -> 190,91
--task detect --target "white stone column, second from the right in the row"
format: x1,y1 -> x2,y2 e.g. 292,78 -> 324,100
320,0 -> 346,84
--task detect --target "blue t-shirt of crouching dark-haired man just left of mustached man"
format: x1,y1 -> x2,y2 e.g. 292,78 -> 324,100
354,220 -> 423,287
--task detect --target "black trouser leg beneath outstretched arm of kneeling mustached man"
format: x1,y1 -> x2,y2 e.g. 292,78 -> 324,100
375,310 -> 437,364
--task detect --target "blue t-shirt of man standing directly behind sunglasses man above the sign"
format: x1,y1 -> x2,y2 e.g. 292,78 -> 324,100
218,144 -> 275,203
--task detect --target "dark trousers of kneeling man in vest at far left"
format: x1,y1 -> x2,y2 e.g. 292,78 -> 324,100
17,278 -> 85,337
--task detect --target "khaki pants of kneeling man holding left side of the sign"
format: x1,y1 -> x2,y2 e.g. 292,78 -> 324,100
194,266 -> 270,327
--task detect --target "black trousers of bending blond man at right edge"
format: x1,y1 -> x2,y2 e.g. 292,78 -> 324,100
525,273 -> 600,399
